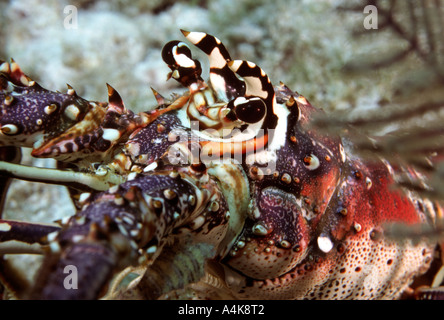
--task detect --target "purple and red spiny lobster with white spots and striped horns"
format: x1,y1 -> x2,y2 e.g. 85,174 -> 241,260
0,31 -> 442,299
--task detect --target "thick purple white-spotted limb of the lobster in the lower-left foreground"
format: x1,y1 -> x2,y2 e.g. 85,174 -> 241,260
28,168 -> 232,299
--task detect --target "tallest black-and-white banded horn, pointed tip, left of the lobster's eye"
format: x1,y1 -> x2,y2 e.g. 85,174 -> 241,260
181,30 -> 245,102
